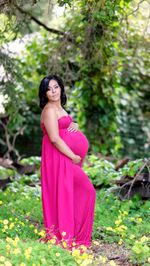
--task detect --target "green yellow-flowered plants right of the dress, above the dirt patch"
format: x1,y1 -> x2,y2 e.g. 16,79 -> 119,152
94,189 -> 150,265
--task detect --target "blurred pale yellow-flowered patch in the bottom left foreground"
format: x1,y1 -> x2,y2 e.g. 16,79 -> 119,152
0,239 -> 78,266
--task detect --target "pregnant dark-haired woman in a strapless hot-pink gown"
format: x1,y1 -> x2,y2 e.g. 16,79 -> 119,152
39,75 -> 96,249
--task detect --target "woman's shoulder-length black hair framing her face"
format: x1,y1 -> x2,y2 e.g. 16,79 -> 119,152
39,75 -> 67,109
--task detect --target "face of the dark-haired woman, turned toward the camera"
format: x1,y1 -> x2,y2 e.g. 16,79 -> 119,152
46,79 -> 61,102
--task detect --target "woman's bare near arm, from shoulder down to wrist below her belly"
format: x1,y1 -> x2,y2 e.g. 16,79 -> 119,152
43,108 -> 76,160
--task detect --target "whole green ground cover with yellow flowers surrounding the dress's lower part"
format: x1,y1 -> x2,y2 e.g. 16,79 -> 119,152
0,156 -> 150,266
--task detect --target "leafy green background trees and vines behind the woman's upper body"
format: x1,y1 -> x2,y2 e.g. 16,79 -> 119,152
0,0 -> 150,158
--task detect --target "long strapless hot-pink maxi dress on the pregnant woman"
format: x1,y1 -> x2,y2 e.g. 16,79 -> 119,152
41,115 -> 96,249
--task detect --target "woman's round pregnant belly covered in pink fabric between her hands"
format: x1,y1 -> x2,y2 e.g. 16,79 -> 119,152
61,130 -> 89,158
